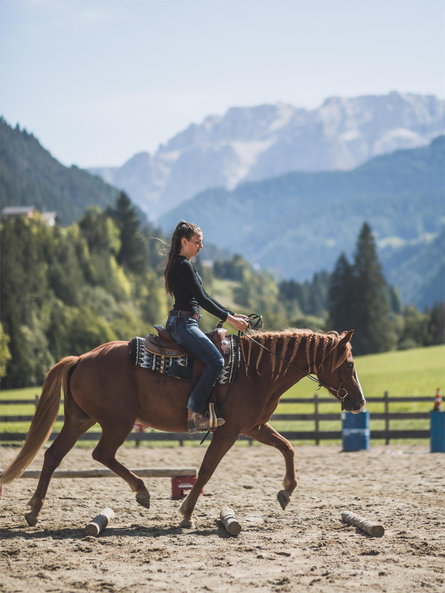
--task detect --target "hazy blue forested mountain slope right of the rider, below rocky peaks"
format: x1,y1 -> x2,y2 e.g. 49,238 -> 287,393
160,136 -> 445,306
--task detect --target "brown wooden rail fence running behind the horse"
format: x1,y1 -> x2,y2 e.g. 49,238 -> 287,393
0,392 -> 434,446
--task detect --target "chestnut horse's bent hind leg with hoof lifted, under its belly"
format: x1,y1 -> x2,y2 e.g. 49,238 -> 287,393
93,419 -> 150,509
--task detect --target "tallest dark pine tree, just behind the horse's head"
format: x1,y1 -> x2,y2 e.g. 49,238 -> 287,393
351,222 -> 394,354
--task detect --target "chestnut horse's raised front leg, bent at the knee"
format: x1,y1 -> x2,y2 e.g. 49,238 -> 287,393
244,423 -> 297,510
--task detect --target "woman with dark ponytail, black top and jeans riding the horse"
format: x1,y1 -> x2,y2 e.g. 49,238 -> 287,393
163,220 -> 248,432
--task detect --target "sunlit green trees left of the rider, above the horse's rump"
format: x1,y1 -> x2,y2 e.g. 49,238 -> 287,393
0,194 -> 168,388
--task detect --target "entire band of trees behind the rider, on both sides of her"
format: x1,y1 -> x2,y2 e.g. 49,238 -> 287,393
0,193 -> 445,388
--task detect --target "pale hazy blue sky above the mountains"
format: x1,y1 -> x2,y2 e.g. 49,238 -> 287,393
0,0 -> 445,167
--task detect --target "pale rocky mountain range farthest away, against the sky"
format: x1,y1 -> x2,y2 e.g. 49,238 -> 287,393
90,92 -> 445,220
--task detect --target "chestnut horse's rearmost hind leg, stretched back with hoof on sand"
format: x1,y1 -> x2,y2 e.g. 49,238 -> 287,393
25,412 -> 94,526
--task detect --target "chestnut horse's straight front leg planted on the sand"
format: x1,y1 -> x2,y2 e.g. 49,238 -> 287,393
179,425 -> 238,527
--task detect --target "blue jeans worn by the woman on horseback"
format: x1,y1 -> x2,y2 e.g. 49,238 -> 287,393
166,315 -> 224,414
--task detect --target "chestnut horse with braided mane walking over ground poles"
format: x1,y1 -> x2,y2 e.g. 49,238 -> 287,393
0,329 -> 365,527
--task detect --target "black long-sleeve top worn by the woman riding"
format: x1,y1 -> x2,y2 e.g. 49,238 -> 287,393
167,255 -> 233,321
